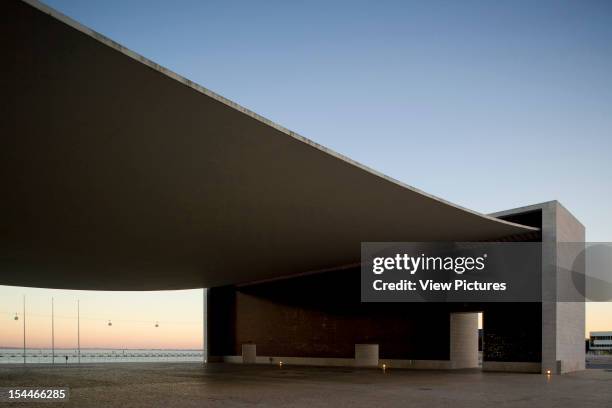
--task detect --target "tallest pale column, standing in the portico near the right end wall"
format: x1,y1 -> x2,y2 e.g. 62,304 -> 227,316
450,313 -> 478,368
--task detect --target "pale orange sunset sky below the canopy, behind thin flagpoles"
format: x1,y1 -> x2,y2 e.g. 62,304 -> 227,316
0,286 -> 203,349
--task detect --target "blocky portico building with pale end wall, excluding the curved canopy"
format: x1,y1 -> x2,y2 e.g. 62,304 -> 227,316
207,202 -> 585,373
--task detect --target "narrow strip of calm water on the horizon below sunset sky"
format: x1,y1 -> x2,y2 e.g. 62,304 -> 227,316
0,348 -> 203,364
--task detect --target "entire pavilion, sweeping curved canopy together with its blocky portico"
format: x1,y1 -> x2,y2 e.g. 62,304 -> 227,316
0,0 -> 584,373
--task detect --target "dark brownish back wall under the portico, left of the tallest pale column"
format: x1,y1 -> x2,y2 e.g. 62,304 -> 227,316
209,269 -> 450,360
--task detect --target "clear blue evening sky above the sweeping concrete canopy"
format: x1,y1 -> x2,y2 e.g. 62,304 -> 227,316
0,0 -> 612,350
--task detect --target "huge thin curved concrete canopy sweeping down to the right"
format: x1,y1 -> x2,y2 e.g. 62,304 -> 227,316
0,1 -> 533,290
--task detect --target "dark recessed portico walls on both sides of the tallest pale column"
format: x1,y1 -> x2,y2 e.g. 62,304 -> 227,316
209,270 -> 541,368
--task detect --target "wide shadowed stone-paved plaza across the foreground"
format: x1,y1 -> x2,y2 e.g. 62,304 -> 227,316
0,363 -> 612,408
